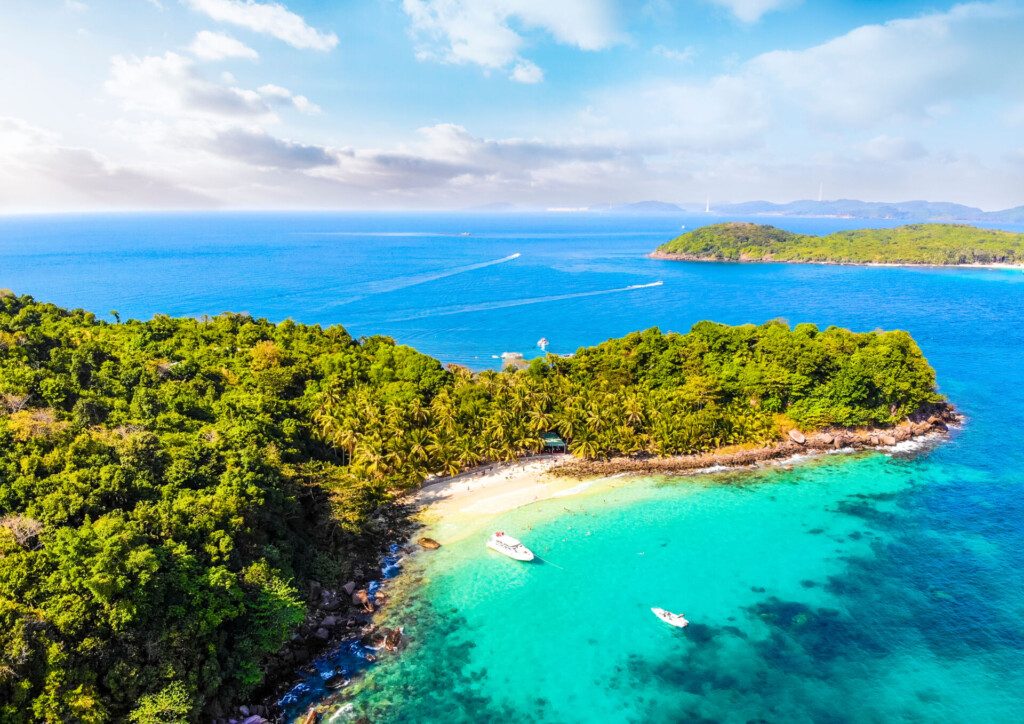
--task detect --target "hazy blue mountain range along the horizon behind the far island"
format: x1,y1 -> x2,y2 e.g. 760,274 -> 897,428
466,199 -> 1024,223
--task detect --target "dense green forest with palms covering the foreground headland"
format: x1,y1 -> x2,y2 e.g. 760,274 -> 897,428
0,292 -> 940,723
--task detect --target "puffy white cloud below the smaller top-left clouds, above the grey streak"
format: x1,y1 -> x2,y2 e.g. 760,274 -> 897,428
105,52 -> 318,118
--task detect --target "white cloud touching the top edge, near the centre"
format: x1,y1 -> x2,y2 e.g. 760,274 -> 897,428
402,0 -> 623,83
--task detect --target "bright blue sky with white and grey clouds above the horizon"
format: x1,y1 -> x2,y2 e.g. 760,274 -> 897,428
0,0 -> 1024,212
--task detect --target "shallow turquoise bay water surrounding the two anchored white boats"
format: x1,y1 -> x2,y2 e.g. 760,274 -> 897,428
350,453 -> 1024,722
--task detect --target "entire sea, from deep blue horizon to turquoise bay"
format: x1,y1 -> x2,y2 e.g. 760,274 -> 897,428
0,214 -> 1024,722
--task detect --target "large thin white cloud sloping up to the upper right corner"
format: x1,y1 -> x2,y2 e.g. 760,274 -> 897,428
590,3 -> 1024,154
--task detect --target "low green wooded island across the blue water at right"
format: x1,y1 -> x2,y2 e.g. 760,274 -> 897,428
651,222 -> 1024,266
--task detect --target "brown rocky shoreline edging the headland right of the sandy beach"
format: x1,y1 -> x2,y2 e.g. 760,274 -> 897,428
551,402 -> 964,477
